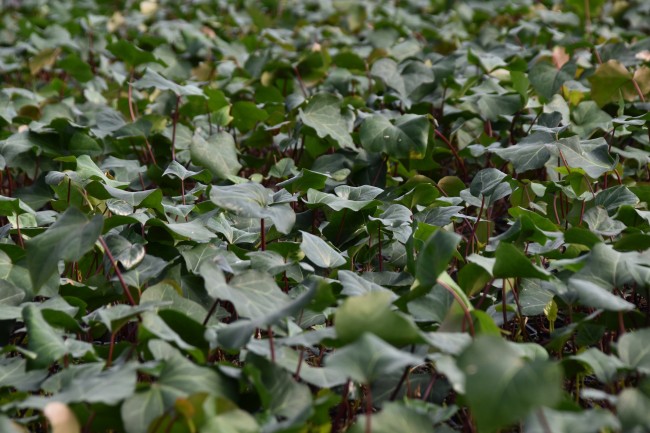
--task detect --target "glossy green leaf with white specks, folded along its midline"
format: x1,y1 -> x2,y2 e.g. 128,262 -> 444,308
359,114 -> 429,159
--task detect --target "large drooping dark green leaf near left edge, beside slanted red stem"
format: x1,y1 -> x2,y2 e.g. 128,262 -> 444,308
26,207 -> 103,290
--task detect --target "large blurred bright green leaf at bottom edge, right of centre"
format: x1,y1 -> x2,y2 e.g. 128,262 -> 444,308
458,336 -> 562,432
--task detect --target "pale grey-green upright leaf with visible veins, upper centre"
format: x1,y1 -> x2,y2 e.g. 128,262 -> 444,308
300,93 -> 355,149
